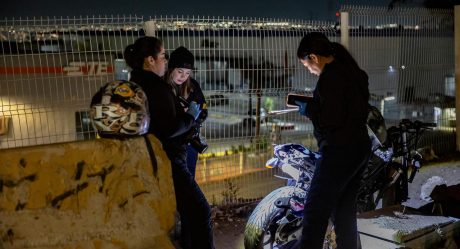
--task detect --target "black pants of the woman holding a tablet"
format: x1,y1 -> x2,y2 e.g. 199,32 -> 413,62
300,142 -> 371,249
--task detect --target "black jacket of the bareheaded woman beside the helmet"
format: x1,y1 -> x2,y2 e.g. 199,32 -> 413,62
130,69 -> 194,145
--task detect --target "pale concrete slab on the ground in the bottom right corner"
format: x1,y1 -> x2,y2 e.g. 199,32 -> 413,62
358,206 -> 460,249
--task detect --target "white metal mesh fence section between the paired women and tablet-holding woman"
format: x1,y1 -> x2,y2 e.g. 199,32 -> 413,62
152,17 -> 335,204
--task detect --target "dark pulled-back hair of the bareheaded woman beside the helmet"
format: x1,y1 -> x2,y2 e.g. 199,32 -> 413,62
123,36 -> 163,69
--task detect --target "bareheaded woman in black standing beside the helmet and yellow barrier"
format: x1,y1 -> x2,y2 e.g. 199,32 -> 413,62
124,37 -> 214,249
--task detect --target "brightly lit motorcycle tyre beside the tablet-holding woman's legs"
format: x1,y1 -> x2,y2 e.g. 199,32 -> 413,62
244,186 -> 294,249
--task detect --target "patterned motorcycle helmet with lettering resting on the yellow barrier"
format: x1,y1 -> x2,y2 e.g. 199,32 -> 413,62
90,80 -> 150,137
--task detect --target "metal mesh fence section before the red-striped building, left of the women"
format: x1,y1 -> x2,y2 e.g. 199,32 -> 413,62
0,17 -> 146,148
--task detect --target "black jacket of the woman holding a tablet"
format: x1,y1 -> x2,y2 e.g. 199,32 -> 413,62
307,59 -> 369,148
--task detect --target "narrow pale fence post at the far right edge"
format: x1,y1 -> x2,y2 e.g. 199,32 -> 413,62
454,5 -> 460,151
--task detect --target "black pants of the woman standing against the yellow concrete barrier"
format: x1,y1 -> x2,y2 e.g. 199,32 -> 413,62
164,144 -> 214,249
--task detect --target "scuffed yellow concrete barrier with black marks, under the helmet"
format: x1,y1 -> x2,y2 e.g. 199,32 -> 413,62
0,136 -> 176,249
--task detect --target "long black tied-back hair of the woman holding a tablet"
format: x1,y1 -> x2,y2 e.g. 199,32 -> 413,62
297,32 -> 359,68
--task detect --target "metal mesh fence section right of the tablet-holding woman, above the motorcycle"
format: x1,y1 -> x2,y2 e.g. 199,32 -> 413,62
341,6 -> 456,158
